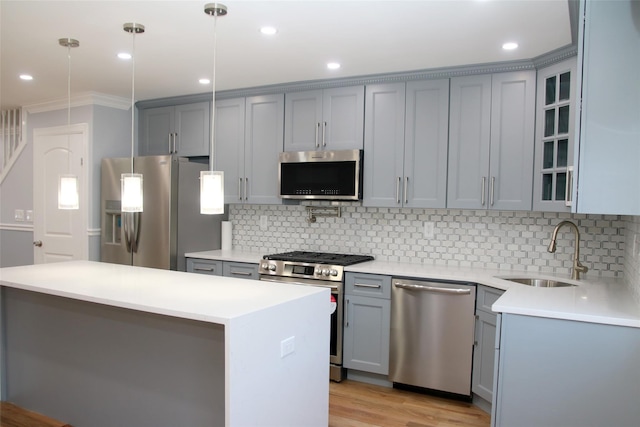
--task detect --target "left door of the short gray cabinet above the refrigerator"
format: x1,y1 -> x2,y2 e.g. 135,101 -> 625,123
138,107 -> 175,156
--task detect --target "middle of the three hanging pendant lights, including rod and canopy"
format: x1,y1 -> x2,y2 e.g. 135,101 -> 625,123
120,22 -> 144,212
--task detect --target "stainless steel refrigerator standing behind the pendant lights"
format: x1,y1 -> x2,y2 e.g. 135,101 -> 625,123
100,156 -> 228,271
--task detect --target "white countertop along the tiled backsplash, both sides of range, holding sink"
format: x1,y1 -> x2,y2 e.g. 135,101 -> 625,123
188,251 -> 640,328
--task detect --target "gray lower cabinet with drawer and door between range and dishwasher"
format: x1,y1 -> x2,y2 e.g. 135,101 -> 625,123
343,273 -> 391,375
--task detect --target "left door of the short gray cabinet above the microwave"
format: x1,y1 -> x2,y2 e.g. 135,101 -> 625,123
284,90 -> 322,151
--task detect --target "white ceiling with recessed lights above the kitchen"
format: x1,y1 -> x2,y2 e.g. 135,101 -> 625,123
0,0 -> 572,109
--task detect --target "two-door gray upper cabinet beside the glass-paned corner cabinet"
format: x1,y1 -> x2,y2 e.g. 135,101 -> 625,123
447,71 -> 536,210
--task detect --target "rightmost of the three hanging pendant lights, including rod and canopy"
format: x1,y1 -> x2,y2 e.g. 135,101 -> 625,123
200,3 -> 227,215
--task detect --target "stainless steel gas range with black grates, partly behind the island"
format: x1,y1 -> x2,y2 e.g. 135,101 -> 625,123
258,251 -> 373,381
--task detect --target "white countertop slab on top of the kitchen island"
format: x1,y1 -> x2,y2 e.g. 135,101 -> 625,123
0,261 -> 327,325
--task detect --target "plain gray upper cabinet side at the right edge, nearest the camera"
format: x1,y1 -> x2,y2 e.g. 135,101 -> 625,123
575,0 -> 640,215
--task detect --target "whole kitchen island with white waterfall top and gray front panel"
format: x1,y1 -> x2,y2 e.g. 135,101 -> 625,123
0,261 -> 330,427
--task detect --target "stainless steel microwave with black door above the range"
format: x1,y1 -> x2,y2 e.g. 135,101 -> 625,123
278,150 -> 363,200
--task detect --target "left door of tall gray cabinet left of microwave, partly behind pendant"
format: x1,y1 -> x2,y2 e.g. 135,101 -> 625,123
213,98 -> 245,203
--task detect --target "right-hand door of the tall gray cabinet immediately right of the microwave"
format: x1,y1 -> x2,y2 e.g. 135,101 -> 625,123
404,79 -> 449,208
